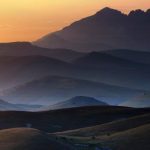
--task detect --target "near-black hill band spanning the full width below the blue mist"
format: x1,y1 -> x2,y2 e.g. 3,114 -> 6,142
0,106 -> 150,133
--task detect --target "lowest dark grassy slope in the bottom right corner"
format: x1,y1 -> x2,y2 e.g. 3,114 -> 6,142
103,124 -> 150,150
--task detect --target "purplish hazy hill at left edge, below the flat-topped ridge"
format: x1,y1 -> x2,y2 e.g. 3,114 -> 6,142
0,55 -> 75,90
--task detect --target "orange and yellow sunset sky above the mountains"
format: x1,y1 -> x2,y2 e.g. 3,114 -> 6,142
0,0 -> 150,42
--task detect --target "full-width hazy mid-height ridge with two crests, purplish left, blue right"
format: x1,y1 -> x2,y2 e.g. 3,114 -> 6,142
0,49 -> 150,92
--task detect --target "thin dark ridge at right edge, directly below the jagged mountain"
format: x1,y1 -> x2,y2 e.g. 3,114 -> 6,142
104,49 -> 150,64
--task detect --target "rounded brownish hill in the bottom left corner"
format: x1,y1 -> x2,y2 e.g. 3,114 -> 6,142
0,128 -> 72,150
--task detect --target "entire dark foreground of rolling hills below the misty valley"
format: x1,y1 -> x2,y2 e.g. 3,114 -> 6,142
0,106 -> 150,150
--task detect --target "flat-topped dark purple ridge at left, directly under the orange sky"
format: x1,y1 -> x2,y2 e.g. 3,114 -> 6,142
0,42 -> 84,61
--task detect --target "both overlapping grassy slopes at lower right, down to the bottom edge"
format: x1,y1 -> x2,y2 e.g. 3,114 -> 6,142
54,114 -> 150,150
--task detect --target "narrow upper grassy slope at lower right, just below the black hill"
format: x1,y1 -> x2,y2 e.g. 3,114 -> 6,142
57,114 -> 150,137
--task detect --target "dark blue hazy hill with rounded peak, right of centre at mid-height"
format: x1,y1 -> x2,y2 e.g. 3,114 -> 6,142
73,52 -> 150,90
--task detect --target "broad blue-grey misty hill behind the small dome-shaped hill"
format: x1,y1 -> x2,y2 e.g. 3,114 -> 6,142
0,76 -> 144,105
